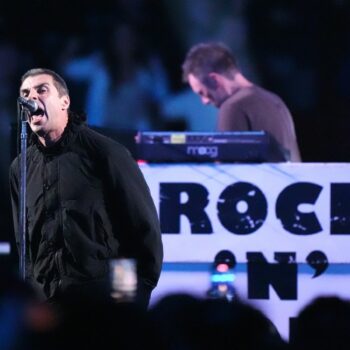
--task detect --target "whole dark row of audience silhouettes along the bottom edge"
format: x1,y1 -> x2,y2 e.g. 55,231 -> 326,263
0,271 -> 350,350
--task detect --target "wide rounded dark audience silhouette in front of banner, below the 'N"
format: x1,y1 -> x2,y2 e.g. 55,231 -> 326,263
149,294 -> 287,350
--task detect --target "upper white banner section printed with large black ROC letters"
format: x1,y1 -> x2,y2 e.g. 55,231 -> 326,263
141,163 -> 350,263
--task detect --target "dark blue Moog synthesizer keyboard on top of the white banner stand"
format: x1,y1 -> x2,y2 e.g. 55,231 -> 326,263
136,131 -> 289,163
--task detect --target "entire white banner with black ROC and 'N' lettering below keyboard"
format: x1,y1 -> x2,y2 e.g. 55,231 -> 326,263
141,163 -> 350,339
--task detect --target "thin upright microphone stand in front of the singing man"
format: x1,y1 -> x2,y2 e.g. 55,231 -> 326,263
18,105 -> 29,280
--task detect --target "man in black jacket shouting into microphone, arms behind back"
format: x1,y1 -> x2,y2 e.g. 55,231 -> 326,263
10,68 -> 163,306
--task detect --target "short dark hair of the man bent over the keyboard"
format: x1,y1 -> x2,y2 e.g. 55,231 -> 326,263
182,43 -> 238,82
